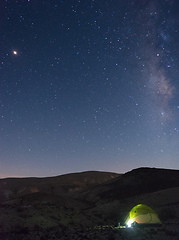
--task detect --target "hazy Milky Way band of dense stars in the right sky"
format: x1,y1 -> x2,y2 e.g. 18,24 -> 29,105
134,1 -> 178,126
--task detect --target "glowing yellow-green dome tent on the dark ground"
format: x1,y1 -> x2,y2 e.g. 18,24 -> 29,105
125,204 -> 162,227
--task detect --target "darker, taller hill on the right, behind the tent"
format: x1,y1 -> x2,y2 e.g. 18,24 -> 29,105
79,168 -> 179,201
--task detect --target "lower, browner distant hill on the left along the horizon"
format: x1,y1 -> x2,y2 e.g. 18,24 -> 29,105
0,171 -> 120,203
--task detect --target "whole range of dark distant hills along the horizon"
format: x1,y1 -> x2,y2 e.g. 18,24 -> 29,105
0,168 -> 179,203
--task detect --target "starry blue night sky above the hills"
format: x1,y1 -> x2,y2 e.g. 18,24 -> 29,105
0,0 -> 179,178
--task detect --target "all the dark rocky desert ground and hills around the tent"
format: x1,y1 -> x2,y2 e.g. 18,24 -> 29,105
0,168 -> 179,240
